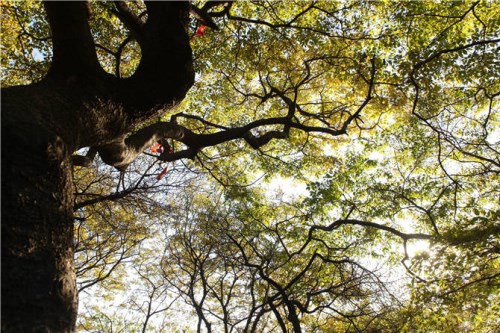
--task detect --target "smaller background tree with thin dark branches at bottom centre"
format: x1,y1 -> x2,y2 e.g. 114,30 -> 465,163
158,187 -> 408,332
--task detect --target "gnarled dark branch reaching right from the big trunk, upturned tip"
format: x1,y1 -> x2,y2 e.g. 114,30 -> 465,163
73,53 -> 376,171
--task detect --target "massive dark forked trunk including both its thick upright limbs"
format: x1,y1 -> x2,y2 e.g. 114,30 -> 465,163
2,2 -> 194,333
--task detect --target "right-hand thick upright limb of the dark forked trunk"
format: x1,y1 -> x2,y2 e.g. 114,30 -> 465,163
119,1 -> 194,118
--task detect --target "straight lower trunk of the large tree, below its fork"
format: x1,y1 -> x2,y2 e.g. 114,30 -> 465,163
2,89 -> 77,333
